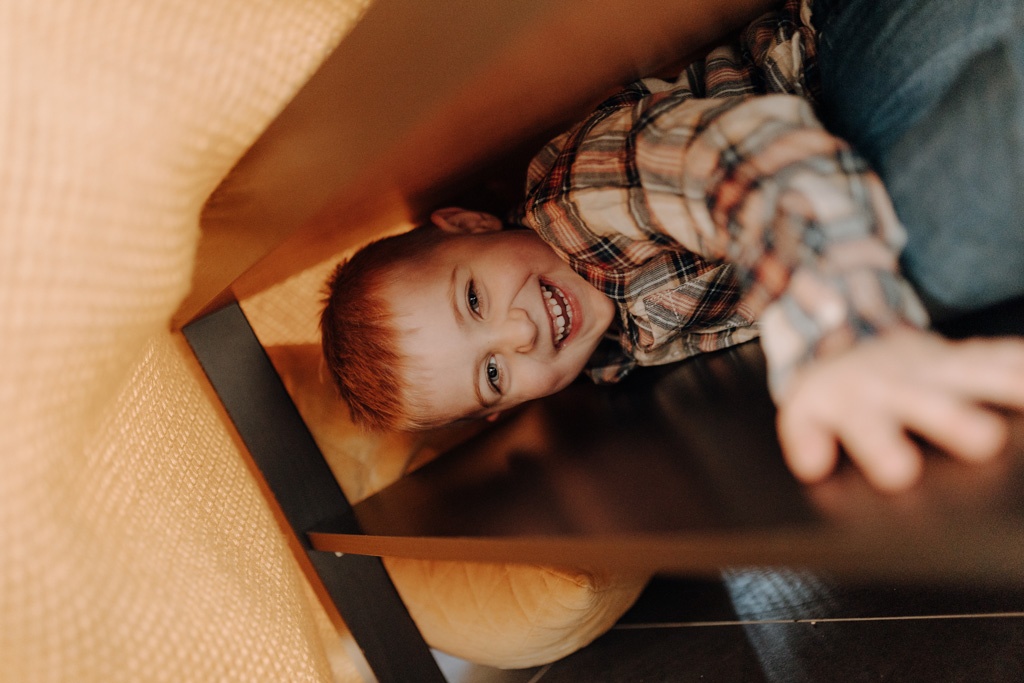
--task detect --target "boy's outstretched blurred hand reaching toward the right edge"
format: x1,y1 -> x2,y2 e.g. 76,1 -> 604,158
778,329 -> 1024,490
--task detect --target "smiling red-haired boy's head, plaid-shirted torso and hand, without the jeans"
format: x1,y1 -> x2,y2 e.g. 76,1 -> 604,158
322,2 -> 1024,489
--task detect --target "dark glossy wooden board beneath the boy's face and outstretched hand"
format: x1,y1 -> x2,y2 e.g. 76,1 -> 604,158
309,302 -> 1024,583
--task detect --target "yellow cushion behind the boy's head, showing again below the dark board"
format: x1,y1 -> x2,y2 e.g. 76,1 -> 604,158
242,258 -> 649,668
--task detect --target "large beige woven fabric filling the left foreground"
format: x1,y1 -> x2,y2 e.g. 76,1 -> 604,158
0,0 -> 372,683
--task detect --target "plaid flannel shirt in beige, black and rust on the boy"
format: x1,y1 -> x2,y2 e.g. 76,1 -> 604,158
517,0 -> 926,396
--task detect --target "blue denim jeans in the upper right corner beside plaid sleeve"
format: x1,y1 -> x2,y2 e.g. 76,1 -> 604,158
813,0 -> 1024,318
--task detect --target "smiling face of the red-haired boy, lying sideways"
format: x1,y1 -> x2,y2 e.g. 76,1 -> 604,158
383,230 -> 614,421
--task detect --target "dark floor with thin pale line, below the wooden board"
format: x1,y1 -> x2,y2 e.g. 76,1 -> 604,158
438,569 -> 1024,683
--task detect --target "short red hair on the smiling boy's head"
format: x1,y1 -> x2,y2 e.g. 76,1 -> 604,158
321,225 -> 445,431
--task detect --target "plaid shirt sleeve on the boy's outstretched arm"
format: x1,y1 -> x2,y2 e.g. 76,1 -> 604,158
532,91 -> 927,399
